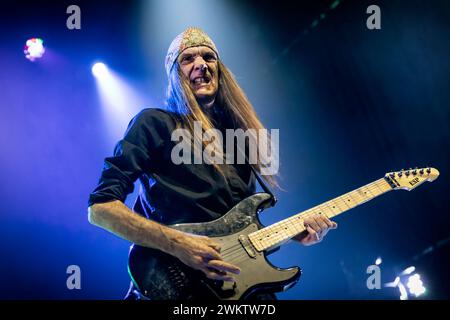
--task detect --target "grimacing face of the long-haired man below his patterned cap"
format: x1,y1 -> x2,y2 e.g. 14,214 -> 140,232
178,46 -> 219,105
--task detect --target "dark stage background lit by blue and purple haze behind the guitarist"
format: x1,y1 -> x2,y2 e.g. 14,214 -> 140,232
0,0 -> 450,299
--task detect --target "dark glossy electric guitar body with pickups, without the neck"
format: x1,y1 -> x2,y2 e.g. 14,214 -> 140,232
128,193 -> 301,300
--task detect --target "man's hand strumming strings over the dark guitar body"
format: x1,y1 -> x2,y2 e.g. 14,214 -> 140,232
173,233 -> 240,281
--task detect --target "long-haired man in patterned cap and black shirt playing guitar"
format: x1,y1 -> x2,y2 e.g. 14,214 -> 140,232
88,28 -> 336,298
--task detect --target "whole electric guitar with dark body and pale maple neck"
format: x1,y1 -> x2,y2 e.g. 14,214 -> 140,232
128,168 -> 439,300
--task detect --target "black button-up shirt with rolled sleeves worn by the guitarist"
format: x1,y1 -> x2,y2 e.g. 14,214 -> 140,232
89,108 -> 255,225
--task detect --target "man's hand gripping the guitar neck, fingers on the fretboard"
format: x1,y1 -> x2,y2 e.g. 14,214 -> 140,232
293,213 -> 337,246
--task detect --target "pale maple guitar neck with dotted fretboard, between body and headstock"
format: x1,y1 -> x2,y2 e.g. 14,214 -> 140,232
249,178 -> 392,251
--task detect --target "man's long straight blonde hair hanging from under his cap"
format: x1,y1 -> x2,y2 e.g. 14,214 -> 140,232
166,60 -> 279,187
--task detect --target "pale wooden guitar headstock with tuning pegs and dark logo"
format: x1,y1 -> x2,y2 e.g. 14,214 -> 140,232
384,168 -> 439,191
